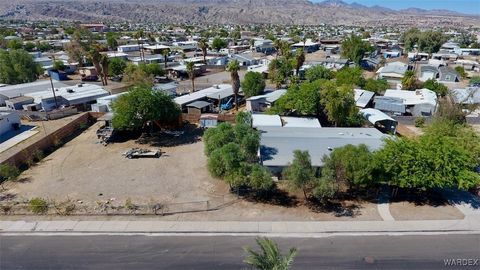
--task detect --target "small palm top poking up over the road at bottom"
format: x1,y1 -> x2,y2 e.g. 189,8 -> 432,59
244,237 -> 297,270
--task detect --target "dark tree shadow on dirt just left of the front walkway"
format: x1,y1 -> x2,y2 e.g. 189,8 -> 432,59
306,198 -> 361,218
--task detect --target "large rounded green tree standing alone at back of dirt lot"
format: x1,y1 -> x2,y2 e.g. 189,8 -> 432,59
112,87 -> 180,130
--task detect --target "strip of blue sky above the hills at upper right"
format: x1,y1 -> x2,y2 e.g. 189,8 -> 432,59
314,0 -> 480,15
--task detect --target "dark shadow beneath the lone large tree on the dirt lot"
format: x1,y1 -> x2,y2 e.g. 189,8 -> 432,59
135,124 -> 203,147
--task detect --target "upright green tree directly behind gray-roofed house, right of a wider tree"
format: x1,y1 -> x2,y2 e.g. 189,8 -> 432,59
320,83 -> 361,127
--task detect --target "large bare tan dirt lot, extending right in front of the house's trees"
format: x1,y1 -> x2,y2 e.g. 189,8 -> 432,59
3,124 -> 380,221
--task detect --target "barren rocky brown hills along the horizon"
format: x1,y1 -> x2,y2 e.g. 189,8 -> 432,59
0,0 -> 480,25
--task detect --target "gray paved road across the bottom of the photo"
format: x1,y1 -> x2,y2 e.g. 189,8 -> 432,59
0,235 -> 480,270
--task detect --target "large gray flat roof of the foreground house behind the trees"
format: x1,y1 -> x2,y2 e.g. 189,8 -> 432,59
260,127 -> 389,167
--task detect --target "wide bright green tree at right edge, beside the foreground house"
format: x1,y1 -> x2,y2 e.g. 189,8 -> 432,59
376,135 -> 480,190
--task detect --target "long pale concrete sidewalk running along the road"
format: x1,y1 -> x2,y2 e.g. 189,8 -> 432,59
0,216 -> 480,234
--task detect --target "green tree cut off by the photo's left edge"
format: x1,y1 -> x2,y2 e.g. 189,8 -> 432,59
0,49 -> 42,84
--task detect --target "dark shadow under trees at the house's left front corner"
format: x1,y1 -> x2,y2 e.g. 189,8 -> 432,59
238,188 -> 299,208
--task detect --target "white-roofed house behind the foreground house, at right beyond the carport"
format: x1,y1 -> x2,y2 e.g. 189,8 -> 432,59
375,89 -> 438,116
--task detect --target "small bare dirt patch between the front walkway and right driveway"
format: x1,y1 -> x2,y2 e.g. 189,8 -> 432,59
390,202 -> 464,220
